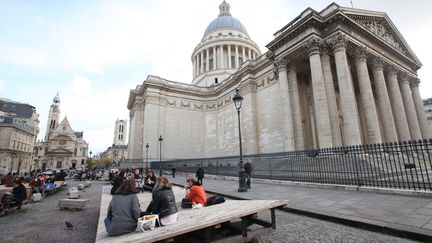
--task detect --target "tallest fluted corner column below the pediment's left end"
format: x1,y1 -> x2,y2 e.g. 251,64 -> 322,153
331,34 -> 361,146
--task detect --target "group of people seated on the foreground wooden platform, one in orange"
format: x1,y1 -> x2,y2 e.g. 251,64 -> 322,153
104,166 -> 213,236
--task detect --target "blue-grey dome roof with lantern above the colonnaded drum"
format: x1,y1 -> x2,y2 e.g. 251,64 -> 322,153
204,1 -> 249,37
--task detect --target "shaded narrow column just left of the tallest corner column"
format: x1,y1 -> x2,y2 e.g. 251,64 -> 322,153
321,47 -> 342,147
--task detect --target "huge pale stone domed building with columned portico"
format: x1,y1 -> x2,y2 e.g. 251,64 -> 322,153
128,2 -> 431,160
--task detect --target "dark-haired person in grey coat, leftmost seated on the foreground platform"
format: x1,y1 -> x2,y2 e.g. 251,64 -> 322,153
104,177 -> 141,235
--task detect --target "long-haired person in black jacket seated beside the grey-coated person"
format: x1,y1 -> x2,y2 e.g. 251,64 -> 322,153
146,176 -> 178,226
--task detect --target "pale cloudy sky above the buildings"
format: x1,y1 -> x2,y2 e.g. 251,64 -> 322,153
0,0 -> 432,154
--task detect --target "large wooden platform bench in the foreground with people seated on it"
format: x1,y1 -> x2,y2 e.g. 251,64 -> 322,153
96,187 -> 287,242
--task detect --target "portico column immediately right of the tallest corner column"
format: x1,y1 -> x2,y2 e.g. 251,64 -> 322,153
355,47 -> 382,144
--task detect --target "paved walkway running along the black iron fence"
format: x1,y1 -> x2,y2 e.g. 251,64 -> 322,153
171,173 -> 432,240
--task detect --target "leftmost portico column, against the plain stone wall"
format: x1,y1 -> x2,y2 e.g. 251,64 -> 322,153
276,58 -> 295,151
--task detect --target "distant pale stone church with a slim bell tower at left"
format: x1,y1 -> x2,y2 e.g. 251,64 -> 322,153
35,94 -> 88,170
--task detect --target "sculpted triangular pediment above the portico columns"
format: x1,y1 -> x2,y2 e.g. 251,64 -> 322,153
342,9 -> 422,66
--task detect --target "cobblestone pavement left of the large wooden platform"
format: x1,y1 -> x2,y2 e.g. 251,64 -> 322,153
0,180 -> 107,243
